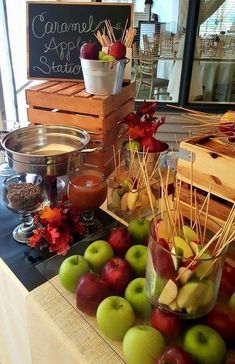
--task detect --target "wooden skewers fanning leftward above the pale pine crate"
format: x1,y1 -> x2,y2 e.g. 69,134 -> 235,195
167,105 -> 235,145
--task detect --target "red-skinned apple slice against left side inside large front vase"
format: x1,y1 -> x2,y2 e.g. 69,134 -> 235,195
150,239 -> 176,280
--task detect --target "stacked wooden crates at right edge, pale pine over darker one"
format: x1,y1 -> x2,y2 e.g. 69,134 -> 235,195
177,135 -> 235,264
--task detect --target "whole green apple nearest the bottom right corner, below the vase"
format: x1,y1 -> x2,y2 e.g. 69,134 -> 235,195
183,325 -> 226,364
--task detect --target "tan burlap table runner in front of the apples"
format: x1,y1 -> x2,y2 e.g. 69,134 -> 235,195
26,276 -> 125,364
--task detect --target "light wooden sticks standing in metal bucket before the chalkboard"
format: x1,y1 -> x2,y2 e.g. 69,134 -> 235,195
95,19 -> 136,48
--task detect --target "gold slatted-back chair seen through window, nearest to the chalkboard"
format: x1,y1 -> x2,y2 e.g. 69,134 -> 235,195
136,51 -> 169,99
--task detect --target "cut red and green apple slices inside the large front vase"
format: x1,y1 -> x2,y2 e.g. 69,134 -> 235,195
146,219 -> 221,317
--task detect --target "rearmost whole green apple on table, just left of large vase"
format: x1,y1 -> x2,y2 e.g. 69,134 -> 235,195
127,218 -> 150,244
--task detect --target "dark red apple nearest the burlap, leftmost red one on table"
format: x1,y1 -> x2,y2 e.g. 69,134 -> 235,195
76,272 -> 111,315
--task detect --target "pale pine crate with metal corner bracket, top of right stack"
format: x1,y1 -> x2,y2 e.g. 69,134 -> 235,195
177,136 -> 235,203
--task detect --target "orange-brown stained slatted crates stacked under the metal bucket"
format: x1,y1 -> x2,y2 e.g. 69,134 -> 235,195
26,81 -> 135,175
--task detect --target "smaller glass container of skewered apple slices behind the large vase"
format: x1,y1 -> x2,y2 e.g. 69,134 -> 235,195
108,146 -> 160,221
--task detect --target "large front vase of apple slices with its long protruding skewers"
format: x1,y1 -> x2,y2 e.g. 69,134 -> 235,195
143,159 -> 235,318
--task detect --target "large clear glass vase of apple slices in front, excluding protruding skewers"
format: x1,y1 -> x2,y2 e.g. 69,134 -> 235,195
146,211 -> 226,319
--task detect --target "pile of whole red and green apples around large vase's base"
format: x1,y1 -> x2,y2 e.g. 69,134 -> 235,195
59,219 -> 235,364
